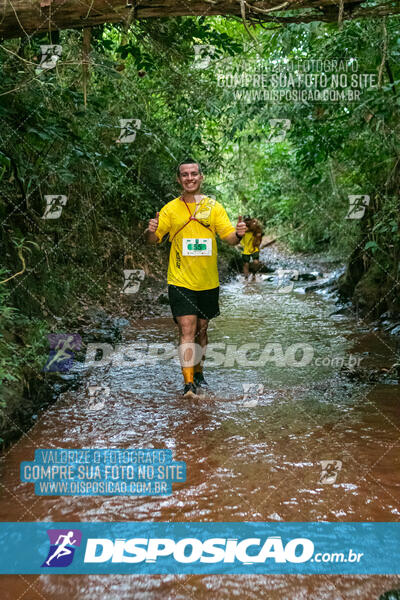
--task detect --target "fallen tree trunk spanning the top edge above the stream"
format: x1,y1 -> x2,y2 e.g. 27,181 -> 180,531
0,0 -> 400,39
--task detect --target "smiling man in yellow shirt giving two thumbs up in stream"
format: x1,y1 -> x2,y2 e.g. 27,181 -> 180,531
145,158 -> 246,397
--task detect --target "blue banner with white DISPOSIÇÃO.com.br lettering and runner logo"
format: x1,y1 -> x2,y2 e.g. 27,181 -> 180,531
0,522 -> 400,575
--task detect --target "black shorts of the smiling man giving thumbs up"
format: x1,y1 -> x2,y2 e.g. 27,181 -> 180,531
168,285 -> 219,323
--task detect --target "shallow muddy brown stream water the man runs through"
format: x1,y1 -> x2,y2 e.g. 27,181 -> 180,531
0,258 -> 400,600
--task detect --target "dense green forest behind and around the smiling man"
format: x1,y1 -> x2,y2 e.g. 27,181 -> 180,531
0,17 -> 400,410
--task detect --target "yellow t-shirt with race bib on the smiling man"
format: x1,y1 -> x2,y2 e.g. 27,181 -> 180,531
156,196 -> 235,291
